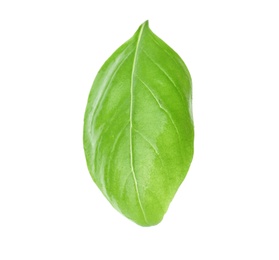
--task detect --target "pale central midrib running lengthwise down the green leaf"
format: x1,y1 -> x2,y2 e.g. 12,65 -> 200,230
130,24 -> 148,223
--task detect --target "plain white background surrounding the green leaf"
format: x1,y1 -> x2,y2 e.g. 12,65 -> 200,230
0,0 -> 279,260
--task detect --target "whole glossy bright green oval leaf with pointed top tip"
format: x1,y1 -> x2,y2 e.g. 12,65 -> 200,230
83,21 -> 194,226
